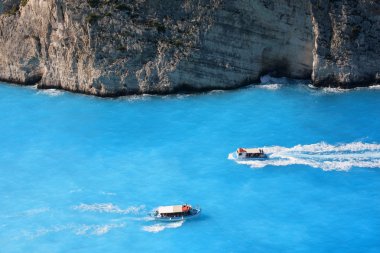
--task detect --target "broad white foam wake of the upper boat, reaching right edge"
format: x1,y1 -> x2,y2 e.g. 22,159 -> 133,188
228,142 -> 380,171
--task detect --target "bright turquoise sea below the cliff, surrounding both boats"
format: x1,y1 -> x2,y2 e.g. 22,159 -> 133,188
0,77 -> 380,253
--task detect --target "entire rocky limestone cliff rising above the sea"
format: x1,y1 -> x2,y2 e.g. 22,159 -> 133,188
0,0 -> 380,96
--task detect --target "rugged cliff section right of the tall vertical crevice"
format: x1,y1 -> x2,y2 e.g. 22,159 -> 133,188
312,0 -> 380,88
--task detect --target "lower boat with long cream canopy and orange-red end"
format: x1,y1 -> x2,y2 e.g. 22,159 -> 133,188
151,204 -> 201,221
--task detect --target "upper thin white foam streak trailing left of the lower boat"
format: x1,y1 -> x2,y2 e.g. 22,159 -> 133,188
73,203 -> 145,214
